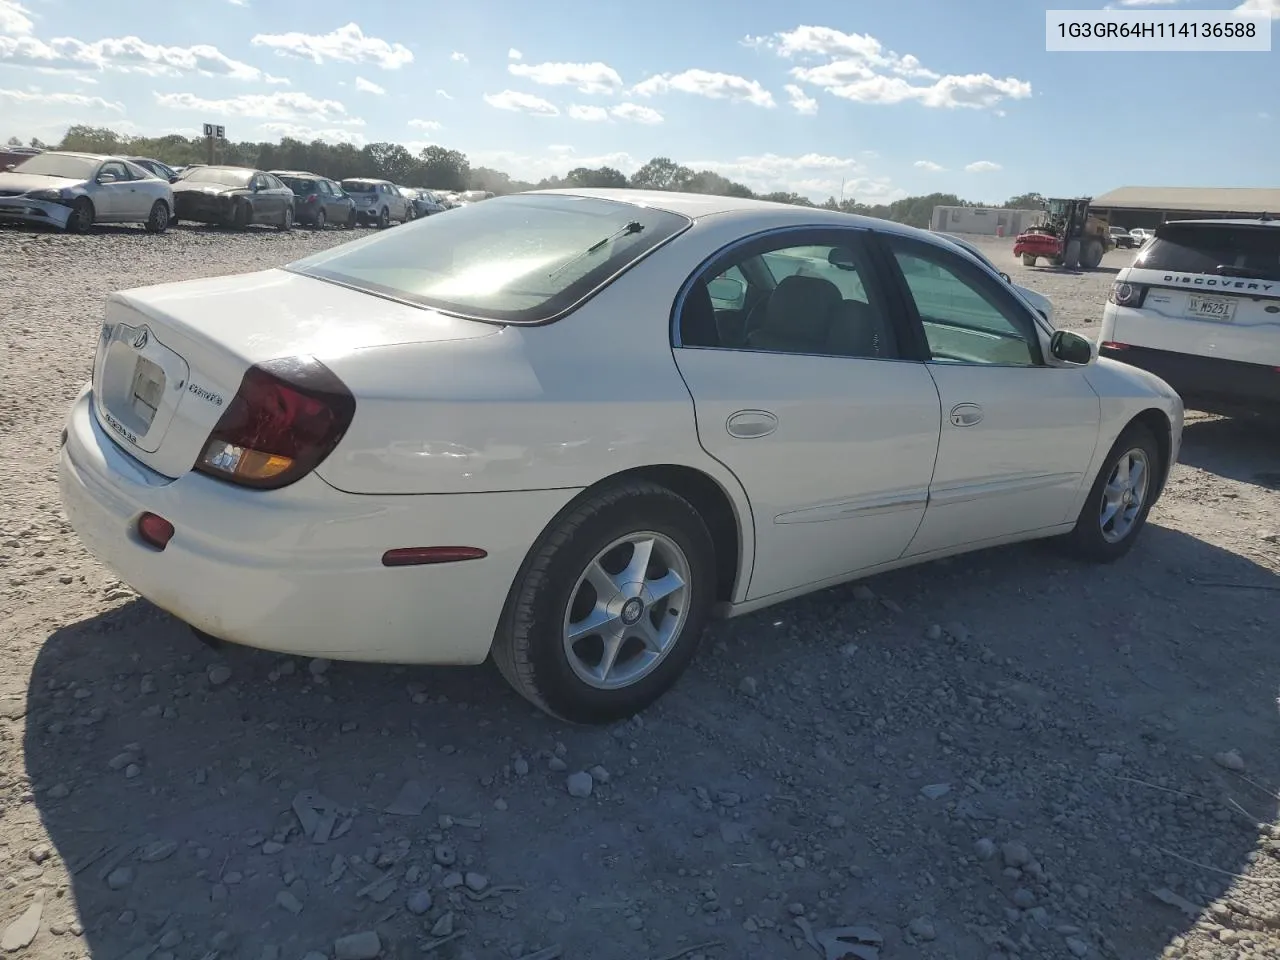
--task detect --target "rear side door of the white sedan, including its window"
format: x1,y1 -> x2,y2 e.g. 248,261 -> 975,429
673,228 -> 940,599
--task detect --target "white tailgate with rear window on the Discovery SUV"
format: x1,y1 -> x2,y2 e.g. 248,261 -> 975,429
1112,220 -> 1280,366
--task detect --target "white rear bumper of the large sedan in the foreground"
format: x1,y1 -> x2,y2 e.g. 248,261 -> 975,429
59,388 -> 576,664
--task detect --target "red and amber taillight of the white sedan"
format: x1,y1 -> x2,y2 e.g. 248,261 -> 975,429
196,357 -> 356,489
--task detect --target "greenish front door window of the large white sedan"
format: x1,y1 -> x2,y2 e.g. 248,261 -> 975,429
888,237 -> 1039,366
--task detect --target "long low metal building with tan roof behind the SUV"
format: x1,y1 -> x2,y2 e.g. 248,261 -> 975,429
1091,187 -> 1280,230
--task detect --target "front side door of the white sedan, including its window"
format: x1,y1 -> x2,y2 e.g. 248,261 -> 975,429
882,234 -> 1101,556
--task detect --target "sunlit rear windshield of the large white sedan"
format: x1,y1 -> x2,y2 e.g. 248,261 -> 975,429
287,195 -> 690,324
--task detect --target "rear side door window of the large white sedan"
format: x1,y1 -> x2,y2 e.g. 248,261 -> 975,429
677,230 -> 900,360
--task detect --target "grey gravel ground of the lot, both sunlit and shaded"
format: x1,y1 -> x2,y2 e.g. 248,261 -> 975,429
0,221 -> 1280,960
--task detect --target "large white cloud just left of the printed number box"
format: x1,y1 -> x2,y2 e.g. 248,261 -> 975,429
742,25 -> 1024,109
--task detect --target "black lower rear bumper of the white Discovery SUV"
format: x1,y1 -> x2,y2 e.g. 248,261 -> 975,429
1098,346 -> 1280,416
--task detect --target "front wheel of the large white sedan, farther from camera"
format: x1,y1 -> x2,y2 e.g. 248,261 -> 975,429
1065,424 -> 1165,563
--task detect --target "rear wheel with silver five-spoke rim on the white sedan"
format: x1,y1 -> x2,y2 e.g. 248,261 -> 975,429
493,481 -> 716,723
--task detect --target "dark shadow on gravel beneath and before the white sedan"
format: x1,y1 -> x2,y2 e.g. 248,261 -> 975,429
23,525 -> 1280,960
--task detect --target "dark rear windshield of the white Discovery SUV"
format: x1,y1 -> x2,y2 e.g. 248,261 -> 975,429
1133,223 -> 1280,280
